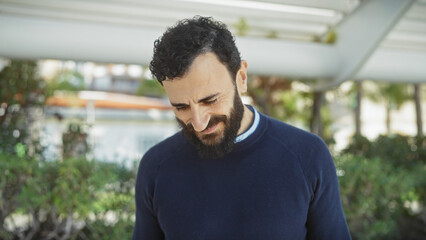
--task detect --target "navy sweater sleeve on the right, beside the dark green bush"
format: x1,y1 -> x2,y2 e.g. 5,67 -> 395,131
306,138 -> 351,240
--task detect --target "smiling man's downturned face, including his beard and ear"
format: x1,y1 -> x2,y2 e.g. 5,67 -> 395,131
163,53 -> 250,158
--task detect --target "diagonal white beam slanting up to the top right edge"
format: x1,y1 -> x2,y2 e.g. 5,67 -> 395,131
314,0 -> 413,90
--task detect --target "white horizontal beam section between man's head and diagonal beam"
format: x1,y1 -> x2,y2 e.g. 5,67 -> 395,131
237,37 -> 339,79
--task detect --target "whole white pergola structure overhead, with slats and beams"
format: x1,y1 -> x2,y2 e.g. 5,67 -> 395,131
0,0 -> 426,90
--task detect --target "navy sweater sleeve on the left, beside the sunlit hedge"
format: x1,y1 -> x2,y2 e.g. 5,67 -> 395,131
132,153 -> 164,240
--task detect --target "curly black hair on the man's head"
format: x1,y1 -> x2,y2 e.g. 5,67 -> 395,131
149,16 -> 241,84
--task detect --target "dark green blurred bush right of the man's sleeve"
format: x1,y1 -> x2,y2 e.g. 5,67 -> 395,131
342,135 -> 426,239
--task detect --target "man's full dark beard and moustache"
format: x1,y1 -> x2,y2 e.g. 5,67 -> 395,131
176,87 -> 244,158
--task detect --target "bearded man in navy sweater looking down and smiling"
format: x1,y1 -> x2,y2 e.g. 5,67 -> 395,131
133,17 -> 350,240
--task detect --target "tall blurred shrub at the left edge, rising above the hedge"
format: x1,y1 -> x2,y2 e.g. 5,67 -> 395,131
0,60 -> 47,156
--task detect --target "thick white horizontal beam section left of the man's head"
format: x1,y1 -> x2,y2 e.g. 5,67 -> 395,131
0,15 -> 161,65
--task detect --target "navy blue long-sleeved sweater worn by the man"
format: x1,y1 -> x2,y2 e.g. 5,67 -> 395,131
133,111 -> 350,240
